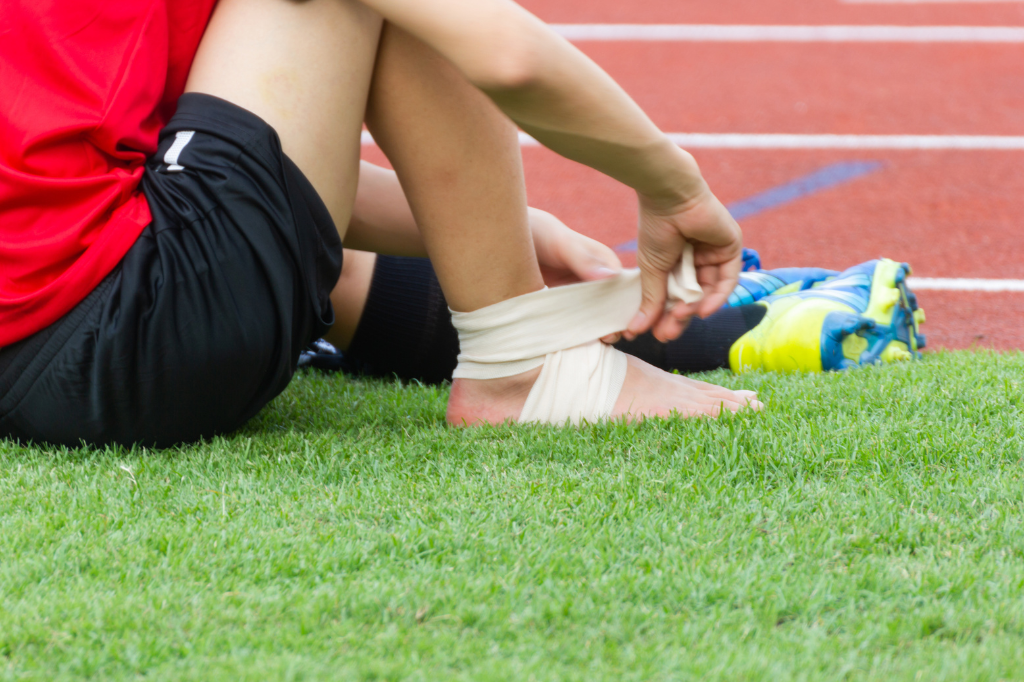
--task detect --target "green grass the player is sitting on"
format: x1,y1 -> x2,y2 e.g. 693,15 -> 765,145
0,352 -> 1024,682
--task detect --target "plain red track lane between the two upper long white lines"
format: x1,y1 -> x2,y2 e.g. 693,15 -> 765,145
580,42 -> 1024,135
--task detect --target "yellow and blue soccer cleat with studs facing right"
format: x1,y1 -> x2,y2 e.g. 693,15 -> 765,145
729,259 -> 925,374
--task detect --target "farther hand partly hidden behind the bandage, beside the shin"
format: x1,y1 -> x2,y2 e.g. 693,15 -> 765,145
529,208 -> 623,287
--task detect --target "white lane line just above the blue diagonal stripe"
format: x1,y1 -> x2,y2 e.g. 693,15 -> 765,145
361,130 -> 1024,151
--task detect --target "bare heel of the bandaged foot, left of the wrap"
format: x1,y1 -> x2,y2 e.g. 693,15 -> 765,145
446,368 -> 541,426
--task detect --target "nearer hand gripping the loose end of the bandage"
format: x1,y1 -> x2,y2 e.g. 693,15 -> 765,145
626,183 -> 742,342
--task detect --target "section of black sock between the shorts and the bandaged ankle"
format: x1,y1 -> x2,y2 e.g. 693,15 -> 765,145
345,256 -> 459,383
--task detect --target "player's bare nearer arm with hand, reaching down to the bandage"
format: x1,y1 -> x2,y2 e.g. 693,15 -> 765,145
362,0 -> 740,337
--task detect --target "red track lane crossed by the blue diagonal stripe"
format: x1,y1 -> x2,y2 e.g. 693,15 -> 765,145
523,148 -> 1024,276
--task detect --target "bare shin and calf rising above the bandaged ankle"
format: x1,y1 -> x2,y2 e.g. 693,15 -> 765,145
367,25 -> 544,310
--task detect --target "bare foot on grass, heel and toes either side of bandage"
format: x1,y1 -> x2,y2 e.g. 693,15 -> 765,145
447,355 -> 764,426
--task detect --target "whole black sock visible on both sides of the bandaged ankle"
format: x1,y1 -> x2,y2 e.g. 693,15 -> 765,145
345,256 -> 765,383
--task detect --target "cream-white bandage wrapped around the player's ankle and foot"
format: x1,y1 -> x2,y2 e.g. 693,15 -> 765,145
452,245 -> 701,424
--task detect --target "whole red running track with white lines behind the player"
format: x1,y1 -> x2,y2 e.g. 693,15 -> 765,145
368,0 -> 1024,349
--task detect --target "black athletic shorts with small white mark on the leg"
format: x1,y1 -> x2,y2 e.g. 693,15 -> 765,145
0,93 -> 341,446
